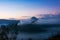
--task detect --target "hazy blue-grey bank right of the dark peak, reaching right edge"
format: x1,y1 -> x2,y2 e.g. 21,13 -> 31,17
36,13 -> 60,24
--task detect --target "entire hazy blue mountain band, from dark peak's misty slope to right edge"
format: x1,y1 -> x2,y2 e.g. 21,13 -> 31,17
18,13 -> 60,25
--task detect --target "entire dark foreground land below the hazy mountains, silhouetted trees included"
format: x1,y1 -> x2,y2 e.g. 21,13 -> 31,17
0,21 -> 60,40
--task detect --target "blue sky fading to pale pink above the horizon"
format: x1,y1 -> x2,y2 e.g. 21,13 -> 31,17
0,0 -> 60,19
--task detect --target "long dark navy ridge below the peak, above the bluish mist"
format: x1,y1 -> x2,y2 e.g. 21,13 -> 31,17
20,24 -> 60,33
